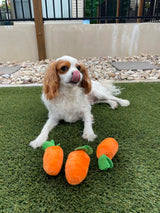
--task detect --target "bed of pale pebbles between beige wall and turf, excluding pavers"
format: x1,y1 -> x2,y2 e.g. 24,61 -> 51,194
0,54 -> 160,86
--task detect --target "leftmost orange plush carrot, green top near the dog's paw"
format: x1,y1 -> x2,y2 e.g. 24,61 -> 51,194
42,140 -> 63,176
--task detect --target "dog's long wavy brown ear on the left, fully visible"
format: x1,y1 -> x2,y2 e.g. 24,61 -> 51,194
43,62 -> 60,100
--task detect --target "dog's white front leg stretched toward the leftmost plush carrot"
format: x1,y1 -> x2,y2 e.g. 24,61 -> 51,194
29,118 -> 58,149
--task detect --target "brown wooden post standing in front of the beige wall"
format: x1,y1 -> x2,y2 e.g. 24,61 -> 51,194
33,0 -> 46,60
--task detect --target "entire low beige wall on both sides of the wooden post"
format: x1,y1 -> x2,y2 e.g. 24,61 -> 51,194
0,22 -> 160,62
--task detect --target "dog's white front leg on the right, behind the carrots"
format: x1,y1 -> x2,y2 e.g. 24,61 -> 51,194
82,111 -> 97,141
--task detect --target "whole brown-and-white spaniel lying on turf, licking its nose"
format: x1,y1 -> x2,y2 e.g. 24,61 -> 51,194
30,56 -> 130,148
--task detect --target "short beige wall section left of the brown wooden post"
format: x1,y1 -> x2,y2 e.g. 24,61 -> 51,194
0,22 -> 38,62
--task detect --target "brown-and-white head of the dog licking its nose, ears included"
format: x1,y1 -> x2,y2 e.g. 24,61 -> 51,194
43,56 -> 91,100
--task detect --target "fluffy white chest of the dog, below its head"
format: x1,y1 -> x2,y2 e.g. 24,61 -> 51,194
42,87 -> 91,122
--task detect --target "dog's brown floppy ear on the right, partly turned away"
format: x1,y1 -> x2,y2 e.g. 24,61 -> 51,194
80,64 -> 91,94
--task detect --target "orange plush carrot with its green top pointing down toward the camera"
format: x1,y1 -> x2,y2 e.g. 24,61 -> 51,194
96,138 -> 118,170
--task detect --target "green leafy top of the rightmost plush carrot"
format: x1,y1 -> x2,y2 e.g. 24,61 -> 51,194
98,155 -> 113,170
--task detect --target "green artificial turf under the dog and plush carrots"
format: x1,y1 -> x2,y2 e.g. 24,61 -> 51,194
0,83 -> 160,213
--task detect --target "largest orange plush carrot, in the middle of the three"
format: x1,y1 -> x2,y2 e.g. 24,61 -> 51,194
65,145 -> 93,185
